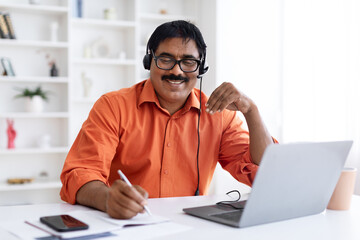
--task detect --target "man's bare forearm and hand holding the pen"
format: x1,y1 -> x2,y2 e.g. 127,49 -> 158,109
76,180 -> 148,219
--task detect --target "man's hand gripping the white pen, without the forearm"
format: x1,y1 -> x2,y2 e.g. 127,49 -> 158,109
106,180 -> 148,219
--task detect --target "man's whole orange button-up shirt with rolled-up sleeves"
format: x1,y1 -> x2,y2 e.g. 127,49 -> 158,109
60,79 -> 257,204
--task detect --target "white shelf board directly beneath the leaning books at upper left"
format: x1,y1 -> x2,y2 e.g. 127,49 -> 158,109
0,39 -> 69,49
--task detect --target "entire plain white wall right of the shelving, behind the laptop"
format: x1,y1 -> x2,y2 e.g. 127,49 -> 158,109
213,0 -> 360,194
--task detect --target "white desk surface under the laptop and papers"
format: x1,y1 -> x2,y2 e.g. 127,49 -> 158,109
0,196 -> 360,240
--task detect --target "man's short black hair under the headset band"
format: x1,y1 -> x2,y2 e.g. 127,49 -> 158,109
147,20 -> 206,59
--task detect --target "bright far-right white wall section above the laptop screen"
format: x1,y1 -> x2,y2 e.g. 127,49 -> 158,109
283,0 -> 360,194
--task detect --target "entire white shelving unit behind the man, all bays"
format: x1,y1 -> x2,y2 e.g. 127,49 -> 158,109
0,0 -> 214,205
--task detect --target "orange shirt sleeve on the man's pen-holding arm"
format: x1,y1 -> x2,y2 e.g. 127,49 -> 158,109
60,96 -> 119,204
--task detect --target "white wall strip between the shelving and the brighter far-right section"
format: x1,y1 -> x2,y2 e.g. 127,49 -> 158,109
211,0 -> 282,194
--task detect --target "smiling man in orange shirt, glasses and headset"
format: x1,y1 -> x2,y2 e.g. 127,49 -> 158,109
60,21 -> 273,218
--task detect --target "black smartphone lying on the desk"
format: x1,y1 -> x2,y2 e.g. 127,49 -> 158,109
40,214 -> 89,232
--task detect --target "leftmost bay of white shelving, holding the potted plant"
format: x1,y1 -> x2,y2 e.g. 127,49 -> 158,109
0,0 -> 70,204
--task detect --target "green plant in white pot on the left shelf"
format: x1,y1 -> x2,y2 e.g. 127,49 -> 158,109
15,86 -> 49,112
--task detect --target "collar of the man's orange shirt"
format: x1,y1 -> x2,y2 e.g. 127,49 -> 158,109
138,78 -> 200,113
